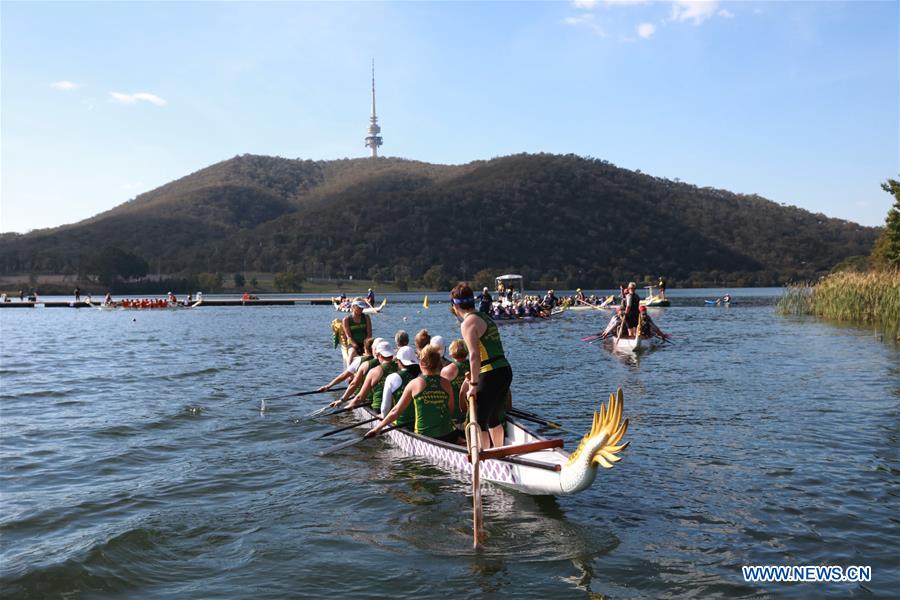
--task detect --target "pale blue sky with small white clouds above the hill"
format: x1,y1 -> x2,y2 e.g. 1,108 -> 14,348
0,0 -> 900,232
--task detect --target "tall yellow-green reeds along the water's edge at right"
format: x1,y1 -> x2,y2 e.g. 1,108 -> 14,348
778,270 -> 900,340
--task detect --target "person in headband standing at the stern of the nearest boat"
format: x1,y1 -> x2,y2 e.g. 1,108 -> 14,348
450,283 -> 512,448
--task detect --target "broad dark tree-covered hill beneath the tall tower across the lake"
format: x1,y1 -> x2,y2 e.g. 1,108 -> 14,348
0,154 -> 880,287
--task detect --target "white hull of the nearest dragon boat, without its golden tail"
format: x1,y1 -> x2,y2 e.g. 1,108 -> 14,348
353,408 -> 596,496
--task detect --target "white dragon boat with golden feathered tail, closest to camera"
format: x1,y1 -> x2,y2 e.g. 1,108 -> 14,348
353,389 -> 628,496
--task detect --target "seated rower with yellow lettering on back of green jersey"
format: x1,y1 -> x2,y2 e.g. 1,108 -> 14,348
366,345 -> 460,443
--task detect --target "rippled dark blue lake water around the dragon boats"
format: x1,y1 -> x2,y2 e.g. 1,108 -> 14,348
0,290 -> 900,599
